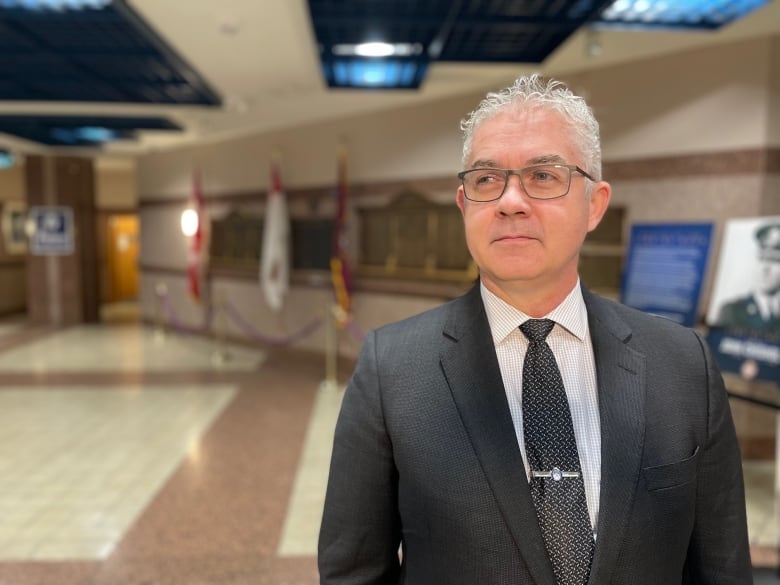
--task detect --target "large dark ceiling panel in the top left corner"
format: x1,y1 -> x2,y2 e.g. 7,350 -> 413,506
0,0 -> 221,106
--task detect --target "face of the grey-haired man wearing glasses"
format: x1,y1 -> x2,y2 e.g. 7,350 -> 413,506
457,109 -> 610,300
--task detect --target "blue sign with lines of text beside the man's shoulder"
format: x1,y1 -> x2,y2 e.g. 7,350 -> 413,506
621,223 -> 712,327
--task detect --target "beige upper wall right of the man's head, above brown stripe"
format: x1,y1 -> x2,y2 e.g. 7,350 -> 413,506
573,39 -> 772,161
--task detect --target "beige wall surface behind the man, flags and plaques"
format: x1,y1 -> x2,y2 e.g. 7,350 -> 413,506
138,39 -> 780,354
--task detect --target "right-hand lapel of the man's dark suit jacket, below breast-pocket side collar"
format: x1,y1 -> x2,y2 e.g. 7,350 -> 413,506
583,290 -> 646,584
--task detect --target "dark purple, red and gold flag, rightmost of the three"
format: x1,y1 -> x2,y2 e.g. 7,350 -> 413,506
330,146 -> 352,326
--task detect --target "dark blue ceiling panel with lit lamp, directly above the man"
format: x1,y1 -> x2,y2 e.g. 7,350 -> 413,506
309,0 -> 613,89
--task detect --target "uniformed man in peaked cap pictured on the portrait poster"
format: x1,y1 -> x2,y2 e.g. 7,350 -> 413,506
715,223 -> 780,338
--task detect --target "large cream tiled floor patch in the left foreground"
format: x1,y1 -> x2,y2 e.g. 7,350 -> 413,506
0,386 -> 235,560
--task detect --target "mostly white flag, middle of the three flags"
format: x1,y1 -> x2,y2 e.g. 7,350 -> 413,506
260,162 -> 290,312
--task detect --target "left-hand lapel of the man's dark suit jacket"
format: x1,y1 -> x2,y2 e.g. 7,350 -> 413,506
441,286 -> 555,585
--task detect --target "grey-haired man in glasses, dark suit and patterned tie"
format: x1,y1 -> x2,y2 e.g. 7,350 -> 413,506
319,76 -> 752,585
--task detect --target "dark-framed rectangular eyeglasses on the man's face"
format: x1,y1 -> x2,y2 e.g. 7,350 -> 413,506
458,164 -> 596,203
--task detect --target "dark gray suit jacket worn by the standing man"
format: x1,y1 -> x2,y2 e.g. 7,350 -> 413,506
319,286 -> 752,585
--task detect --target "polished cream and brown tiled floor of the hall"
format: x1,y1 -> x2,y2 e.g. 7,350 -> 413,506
0,308 -> 780,585
